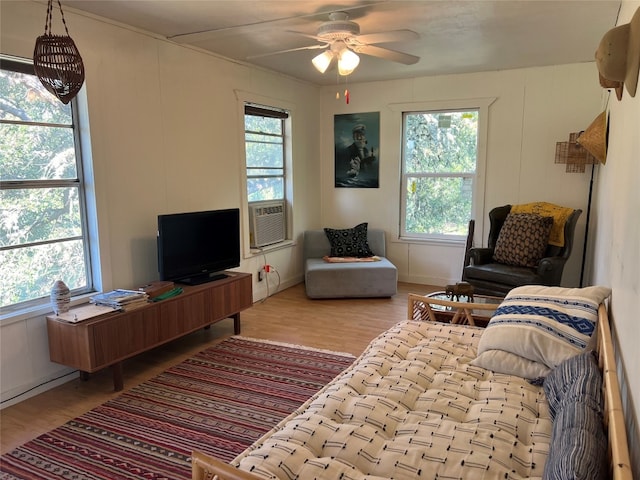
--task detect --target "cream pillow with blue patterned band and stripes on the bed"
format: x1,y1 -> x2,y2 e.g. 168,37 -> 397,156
474,285 -> 611,378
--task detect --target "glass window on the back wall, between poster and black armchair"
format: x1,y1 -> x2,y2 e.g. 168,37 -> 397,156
401,109 -> 480,240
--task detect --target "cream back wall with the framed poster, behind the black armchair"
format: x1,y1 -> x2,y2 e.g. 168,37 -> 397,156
321,63 -> 602,286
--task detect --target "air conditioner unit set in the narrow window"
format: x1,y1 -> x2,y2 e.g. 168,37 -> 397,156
249,200 -> 287,248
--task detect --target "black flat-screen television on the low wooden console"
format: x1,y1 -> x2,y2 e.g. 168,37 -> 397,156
158,208 -> 240,285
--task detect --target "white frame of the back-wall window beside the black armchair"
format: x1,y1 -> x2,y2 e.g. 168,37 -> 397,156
389,97 -> 496,245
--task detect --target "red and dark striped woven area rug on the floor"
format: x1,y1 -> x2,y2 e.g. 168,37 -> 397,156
0,336 -> 354,480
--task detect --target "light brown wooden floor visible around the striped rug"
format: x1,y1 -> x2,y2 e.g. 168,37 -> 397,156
0,283 -> 438,454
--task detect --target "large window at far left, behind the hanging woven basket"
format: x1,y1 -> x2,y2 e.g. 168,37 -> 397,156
0,58 -> 91,310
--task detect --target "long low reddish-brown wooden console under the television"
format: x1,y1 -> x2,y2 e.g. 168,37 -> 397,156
47,272 -> 253,391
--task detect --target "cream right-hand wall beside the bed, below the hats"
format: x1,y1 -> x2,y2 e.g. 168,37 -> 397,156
589,1 -> 640,470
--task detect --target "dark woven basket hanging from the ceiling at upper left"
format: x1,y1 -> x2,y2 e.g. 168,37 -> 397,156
33,0 -> 84,105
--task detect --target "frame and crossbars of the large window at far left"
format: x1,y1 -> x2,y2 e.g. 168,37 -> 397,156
0,55 -> 95,319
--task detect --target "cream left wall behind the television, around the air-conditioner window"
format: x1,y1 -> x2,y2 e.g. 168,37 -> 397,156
0,1 -> 320,407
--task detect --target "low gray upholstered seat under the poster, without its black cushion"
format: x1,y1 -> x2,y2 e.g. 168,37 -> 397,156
303,229 -> 398,298
